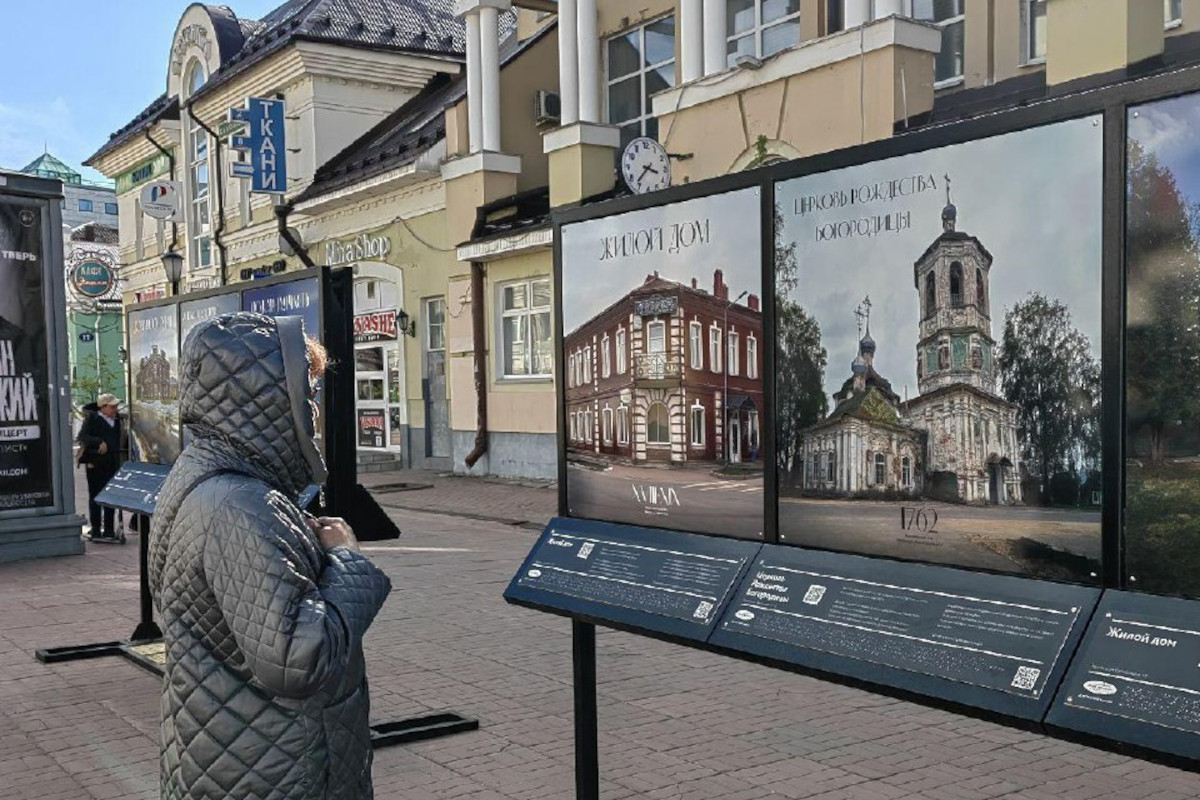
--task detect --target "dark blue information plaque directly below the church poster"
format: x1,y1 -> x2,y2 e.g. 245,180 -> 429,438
710,545 -> 1099,721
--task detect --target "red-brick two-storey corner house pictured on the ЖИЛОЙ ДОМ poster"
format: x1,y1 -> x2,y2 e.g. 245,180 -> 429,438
564,270 -> 763,464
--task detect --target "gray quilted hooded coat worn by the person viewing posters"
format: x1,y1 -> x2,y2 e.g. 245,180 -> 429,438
150,313 -> 391,800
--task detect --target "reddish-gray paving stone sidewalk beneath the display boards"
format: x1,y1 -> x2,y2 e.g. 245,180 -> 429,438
0,479 -> 1200,800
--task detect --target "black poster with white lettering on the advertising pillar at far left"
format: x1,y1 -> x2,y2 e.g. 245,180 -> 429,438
0,200 -> 56,511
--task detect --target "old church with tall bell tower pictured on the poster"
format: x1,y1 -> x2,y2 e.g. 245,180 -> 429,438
802,191 -> 1021,505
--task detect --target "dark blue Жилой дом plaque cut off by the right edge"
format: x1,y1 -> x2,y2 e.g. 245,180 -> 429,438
1046,590 -> 1200,760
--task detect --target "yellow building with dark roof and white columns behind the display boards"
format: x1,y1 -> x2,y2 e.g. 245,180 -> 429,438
89,0 -> 1200,479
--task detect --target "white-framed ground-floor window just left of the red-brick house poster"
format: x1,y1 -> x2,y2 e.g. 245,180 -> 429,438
499,278 -> 554,378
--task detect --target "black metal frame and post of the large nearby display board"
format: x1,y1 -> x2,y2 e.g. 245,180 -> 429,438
530,66 -> 1200,800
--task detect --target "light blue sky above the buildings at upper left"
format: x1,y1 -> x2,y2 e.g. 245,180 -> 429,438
0,0 -> 283,179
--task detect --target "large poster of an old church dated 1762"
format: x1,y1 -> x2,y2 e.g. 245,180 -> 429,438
775,116 -> 1103,583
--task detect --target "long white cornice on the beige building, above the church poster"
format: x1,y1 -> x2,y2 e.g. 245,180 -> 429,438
652,17 -> 942,118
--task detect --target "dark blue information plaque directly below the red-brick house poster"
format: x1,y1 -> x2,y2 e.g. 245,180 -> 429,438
504,518 -> 762,642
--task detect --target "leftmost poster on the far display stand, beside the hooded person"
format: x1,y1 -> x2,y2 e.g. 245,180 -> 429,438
128,305 -> 182,464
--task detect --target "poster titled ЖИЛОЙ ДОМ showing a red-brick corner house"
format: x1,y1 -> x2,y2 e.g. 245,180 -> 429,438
562,187 -> 764,539
